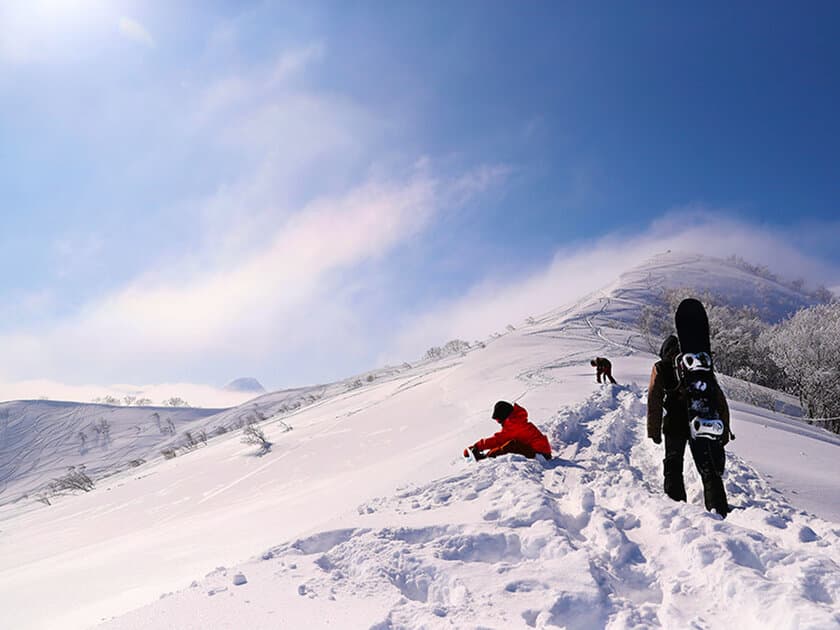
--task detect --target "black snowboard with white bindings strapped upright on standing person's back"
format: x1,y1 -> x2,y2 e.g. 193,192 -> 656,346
674,298 -> 725,441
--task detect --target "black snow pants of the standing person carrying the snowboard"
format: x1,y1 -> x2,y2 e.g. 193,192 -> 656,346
662,433 -> 729,517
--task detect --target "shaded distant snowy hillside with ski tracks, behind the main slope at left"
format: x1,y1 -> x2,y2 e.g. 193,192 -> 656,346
0,368 -> 434,510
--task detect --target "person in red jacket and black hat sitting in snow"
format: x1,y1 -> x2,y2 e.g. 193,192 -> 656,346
464,400 -> 551,459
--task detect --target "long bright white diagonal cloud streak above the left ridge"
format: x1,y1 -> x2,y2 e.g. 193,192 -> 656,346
0,173 -> 440,374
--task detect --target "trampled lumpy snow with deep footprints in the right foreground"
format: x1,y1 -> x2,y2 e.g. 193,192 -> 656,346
108,386 -> 840,630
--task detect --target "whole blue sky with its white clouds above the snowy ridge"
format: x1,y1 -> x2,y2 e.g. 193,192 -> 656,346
0,0 -> 840,400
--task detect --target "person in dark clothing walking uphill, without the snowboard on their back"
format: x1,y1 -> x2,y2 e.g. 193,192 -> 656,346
647,335 -> 731,517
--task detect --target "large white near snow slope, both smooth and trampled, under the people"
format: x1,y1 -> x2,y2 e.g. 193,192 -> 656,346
0,253 -> 840,629
